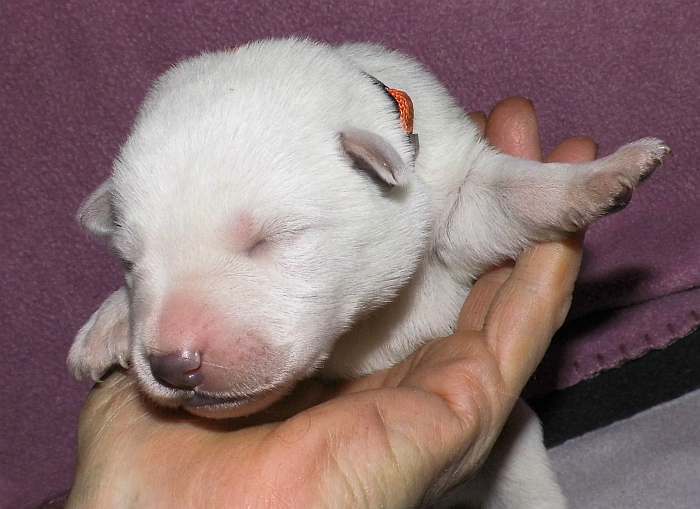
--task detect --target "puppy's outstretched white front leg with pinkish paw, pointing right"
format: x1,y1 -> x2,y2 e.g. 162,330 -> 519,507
435,138 -> 670,278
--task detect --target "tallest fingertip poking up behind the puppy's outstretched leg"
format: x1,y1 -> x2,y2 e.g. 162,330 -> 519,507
486,97 -> 542,161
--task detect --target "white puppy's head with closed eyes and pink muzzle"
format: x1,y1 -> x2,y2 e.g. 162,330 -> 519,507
74,41 -> 430,417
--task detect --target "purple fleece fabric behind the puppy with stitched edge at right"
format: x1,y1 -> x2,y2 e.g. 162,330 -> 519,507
0,0 -> 700,508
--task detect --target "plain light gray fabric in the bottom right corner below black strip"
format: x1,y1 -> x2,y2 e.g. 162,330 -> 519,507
551,391 -> 700,509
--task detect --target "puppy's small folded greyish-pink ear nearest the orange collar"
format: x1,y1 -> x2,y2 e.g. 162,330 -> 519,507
340,128 -> 411,186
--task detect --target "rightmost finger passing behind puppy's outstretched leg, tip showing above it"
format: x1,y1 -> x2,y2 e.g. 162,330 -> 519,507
486,138 -> 597,393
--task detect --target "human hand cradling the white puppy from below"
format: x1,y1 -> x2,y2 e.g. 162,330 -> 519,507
68,99 -> 595,508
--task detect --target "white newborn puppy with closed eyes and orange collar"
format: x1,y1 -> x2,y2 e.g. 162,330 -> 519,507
68,39 -> 668,507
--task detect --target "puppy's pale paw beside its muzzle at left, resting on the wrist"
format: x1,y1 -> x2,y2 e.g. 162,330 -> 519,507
67,288 -> 129,381
